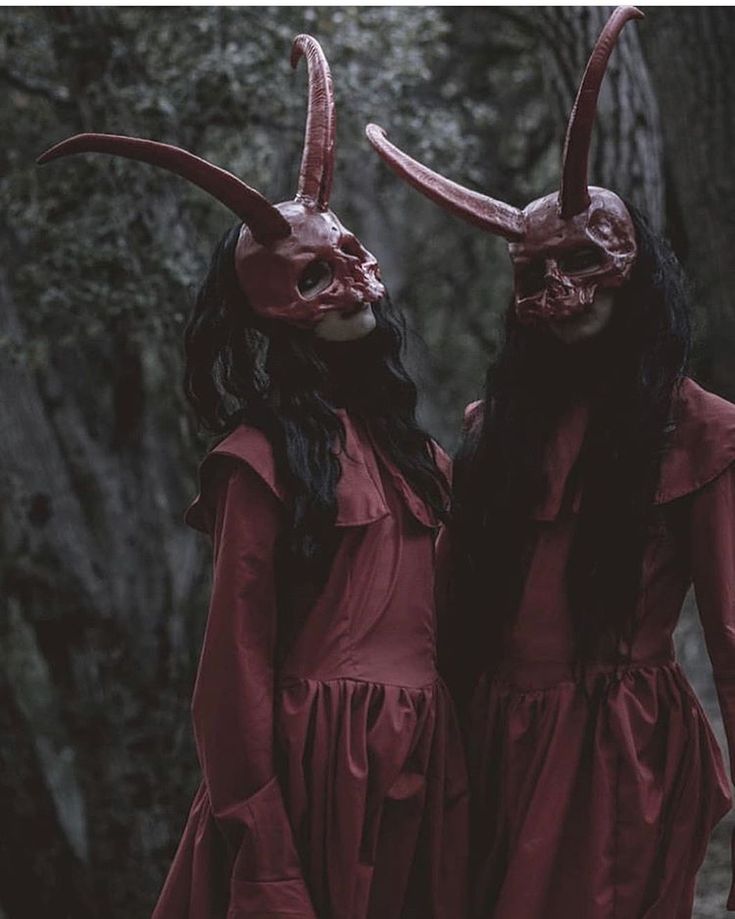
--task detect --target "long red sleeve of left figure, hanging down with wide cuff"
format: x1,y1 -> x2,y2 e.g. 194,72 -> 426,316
192,458 -> 315,919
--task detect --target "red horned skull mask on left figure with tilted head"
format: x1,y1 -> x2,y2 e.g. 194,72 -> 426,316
38,35 -> 385,327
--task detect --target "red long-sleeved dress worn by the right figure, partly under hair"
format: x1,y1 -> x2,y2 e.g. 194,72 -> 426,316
470,380 -> 735,919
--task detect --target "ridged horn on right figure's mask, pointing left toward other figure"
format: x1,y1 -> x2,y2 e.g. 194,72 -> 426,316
365,124 -> 525,240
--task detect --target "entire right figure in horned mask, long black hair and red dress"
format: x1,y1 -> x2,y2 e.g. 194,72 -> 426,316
369,7 -> 735,919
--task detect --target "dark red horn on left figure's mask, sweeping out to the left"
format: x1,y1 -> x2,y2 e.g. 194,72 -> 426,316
36,134 -> 291,245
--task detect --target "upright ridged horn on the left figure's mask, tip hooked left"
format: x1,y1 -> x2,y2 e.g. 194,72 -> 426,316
291,35 -> 336,210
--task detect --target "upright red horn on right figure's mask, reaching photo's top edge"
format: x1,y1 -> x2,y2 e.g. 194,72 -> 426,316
559,6 -> 644,219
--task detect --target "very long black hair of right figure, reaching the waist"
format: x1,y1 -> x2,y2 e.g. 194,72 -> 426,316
451,207 -> 690,696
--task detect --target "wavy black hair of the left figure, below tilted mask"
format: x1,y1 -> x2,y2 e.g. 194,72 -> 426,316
184,226 -> 448,586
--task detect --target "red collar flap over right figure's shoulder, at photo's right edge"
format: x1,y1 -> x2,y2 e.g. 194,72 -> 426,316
656,377 -> 735,504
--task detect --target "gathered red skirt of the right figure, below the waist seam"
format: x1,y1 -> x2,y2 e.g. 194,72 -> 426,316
470,661 -> 730,919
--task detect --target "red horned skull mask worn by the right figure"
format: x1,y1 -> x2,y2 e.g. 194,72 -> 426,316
366,6 -> 643,323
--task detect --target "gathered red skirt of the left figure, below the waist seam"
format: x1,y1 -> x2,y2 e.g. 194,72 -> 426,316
154,678 -> 468,919
